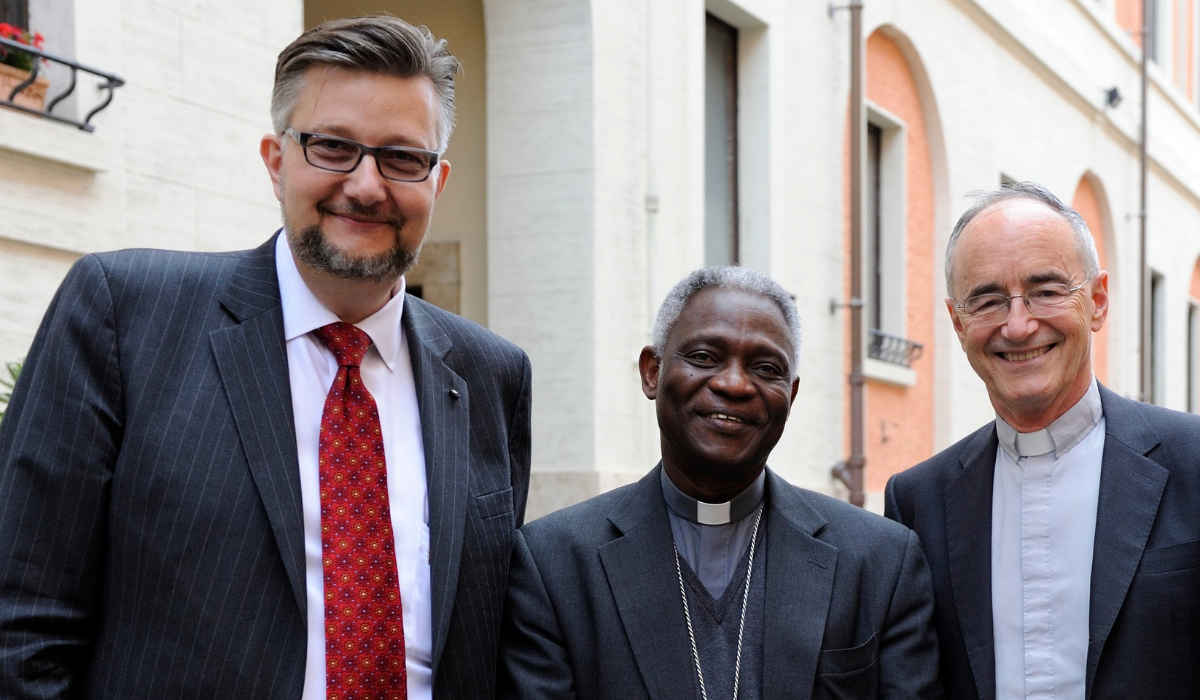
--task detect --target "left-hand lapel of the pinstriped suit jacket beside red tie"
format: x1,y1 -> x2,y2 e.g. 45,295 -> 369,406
209,237 -> 307,624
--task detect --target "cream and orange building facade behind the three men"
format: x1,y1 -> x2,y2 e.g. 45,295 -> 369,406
0,0 -> 1200,515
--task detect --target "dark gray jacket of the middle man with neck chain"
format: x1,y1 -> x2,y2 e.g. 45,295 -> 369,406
499,468 -> 941,700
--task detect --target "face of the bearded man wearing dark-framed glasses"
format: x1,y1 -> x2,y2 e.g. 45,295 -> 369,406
262,66 -> 450,282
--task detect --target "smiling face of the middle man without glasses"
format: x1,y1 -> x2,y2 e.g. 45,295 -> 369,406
640,287 -> 798,502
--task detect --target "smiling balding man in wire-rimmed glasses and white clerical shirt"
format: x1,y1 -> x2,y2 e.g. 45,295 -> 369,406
886,183 -> 1200,700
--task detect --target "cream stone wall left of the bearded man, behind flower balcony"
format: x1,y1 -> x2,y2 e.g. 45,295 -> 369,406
0,0 -> 301,361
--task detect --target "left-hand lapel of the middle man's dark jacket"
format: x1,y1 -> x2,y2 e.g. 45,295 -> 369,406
600,467 -> 697,700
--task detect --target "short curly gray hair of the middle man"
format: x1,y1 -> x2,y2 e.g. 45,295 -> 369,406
650,267 -> 800,377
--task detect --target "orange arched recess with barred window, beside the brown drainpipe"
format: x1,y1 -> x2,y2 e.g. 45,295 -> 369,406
846,26 -> 940,508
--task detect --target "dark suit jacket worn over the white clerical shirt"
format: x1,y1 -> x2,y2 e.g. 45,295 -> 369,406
887,387 -> 1200,700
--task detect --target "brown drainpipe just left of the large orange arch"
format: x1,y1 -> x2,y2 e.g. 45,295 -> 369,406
829,0 -> 866,508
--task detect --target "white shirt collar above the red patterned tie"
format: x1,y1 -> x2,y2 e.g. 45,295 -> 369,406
275,232 -> 407,371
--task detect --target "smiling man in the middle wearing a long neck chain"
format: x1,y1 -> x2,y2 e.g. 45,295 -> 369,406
498,268 -> 941,700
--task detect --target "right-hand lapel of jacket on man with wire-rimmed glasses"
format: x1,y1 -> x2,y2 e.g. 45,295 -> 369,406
1087,387 -> 1169,696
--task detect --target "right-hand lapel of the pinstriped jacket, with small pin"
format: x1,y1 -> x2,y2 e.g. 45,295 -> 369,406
401,297 -> 470,669
